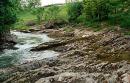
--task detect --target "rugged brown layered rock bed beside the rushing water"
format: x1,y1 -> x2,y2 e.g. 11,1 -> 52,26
0,25 -> 130,83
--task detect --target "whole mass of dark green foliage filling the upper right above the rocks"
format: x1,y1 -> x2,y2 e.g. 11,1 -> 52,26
83,0 -> 130,28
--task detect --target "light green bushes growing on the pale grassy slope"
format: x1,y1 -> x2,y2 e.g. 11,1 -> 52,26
31,5 -> 60,23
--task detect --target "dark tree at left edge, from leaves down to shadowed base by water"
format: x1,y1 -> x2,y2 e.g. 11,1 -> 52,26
0,0 -> 20,48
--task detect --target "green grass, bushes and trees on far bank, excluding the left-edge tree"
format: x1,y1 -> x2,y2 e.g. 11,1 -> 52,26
12,0 -> 130,30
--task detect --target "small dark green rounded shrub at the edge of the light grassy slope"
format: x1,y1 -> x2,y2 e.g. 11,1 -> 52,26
67,2 -> 83,22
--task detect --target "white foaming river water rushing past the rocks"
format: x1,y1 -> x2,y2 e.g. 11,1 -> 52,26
0,32 -> 58,68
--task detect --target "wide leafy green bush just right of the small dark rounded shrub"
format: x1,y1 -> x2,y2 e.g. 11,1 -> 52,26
83,0 -> 110,21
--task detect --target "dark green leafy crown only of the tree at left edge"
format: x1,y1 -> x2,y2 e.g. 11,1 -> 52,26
0,0 -> 19,31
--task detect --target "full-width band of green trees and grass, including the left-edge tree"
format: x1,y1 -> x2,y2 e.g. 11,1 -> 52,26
0,0 -> 130,31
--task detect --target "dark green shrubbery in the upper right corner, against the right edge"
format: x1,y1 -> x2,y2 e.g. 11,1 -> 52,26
108,0 -> 130,29
